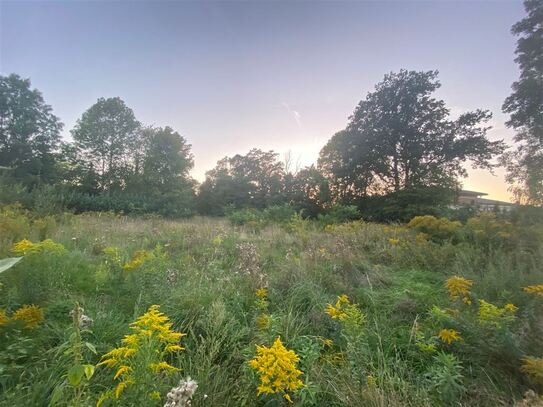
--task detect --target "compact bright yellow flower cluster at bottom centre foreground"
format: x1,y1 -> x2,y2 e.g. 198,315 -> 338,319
249,338 -> 304,402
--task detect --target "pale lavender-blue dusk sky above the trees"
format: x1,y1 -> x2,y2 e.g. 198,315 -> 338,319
0,0 -> 524,200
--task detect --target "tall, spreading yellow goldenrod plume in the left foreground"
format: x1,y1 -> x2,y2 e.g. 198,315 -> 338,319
98,305 -> 185,404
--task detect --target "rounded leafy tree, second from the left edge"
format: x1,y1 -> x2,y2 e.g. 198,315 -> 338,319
72,97 -> 141,192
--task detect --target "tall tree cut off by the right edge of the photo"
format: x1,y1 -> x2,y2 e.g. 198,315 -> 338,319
502,0 -> 543,205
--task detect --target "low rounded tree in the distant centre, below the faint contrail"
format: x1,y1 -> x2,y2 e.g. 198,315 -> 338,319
198,148 -> 284,215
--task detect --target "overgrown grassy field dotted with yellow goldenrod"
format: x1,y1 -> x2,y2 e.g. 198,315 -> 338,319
0,207 -> 543,406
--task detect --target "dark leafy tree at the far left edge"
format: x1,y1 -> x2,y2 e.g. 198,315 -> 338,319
0,74 -> 63,186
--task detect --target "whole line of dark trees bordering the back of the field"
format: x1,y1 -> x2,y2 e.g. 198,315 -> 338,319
0,0 -> 543,219
